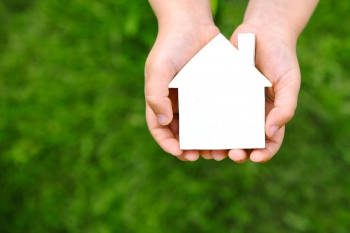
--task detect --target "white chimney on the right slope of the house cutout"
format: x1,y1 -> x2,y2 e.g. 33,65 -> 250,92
238,33 -> 255,66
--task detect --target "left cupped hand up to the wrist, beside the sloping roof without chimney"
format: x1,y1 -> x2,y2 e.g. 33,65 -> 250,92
145,15 -> 223,161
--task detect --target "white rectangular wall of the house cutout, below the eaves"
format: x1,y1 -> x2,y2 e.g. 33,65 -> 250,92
179,87 -> 265,149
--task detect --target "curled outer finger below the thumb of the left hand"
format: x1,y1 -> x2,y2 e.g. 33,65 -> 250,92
146,105 -> 182,156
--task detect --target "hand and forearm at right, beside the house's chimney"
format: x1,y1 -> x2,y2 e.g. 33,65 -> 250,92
221,0 -> 318,162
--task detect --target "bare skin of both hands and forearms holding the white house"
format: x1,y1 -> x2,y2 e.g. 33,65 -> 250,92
145,0 -> 318,163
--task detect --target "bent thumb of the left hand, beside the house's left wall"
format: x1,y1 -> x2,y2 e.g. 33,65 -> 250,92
145,57 -> 175,125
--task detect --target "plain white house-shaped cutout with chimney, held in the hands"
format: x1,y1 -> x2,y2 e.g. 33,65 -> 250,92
169,33 -> 272,150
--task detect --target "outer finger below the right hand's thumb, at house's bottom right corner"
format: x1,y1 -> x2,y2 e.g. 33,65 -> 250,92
250,126 -> 285,163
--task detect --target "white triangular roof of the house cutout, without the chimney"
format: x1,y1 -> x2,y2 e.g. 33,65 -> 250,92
169,34 -> 272,89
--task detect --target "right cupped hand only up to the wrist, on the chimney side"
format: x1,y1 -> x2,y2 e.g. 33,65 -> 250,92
228,23 -> 300,162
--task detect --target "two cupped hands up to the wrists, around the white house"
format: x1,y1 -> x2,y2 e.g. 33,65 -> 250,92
145,13 -> 300,163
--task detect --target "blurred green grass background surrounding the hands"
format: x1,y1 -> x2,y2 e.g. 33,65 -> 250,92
0,0 -> 350,233
